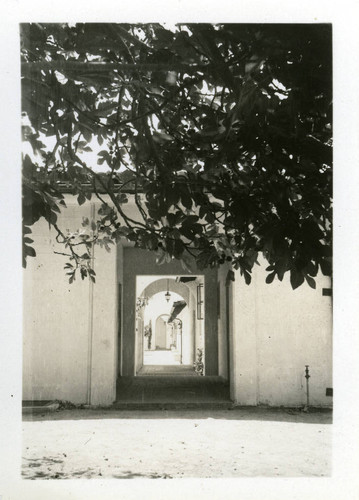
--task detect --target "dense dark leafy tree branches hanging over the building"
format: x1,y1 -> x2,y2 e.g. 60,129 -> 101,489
21,24 -> 332,288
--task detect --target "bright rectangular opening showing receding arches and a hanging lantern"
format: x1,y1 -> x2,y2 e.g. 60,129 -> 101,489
135,275 -> 205,376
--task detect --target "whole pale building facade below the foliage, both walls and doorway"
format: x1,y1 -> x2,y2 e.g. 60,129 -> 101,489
23,196 -> 332,406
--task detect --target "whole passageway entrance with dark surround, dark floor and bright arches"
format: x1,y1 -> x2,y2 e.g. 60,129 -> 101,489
117,247 -> 229,408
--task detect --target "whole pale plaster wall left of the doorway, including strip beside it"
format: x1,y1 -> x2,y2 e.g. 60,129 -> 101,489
23,196 -> 117,405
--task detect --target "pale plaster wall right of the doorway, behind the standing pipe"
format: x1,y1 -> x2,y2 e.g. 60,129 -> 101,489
232,265 -> 332,406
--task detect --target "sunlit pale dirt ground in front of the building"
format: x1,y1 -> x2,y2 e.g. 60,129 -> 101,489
22,408 -> 332,479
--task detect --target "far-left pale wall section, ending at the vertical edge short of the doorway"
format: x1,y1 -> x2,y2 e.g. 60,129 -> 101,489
19,199 -> 90,403
